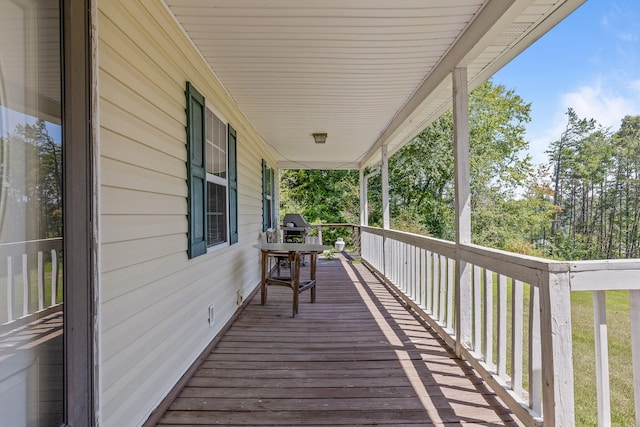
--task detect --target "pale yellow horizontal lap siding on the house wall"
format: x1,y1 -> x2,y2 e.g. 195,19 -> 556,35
97,0 -> 276,427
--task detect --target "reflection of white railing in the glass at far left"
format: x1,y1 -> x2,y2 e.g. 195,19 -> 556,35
0,238 -> 62,332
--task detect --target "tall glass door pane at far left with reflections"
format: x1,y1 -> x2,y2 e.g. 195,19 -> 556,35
0,0 -> 64,427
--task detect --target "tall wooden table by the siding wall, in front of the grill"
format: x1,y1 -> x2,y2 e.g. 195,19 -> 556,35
258,243 -> 330,317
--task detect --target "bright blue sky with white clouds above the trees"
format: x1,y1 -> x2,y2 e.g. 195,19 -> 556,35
493,0 -> 640,164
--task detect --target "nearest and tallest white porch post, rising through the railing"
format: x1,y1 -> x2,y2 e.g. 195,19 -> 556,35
453,68 -> 472,356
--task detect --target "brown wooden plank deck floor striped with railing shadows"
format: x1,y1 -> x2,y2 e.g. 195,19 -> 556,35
157,256 -> 517,426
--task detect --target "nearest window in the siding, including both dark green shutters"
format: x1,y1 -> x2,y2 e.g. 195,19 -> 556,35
186,82 -> 238,258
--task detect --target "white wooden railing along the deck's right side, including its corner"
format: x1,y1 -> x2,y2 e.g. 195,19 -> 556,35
360,226 -> 640,426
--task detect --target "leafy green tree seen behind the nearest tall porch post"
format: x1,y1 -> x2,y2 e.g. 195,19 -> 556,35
389,81 -> 534,247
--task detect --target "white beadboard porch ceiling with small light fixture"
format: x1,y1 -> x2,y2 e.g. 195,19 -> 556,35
165,0 -> 584,169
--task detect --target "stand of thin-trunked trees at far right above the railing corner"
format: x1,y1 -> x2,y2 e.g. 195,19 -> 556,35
548,109 -> 640,259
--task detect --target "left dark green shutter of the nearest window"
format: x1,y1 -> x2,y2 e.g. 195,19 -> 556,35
186,82 -> 207,258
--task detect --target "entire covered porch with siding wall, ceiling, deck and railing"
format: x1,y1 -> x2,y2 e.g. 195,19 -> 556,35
5,0 -> 640,427
